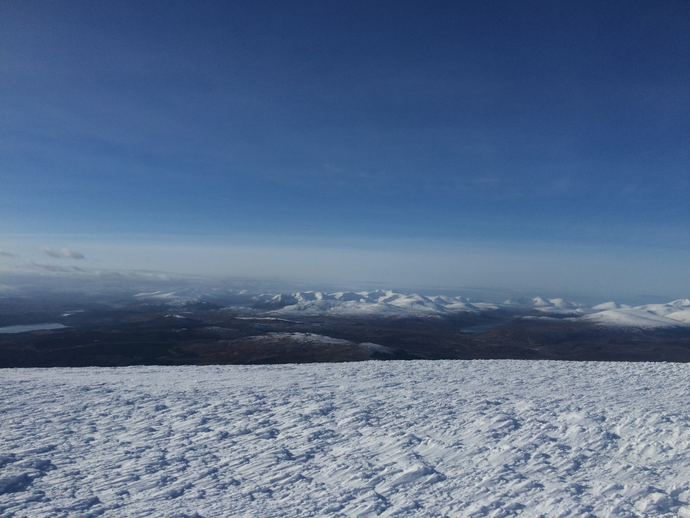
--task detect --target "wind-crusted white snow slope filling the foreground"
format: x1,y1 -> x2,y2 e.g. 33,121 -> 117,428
0,360 -> 690,518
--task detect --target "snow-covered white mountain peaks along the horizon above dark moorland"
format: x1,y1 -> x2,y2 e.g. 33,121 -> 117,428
134,288 -> 690,328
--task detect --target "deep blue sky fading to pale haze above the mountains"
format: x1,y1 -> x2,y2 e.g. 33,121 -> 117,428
0,0 -> 690,297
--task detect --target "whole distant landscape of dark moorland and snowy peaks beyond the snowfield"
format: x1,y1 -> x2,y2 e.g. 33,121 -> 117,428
0,284 -> 690,368
